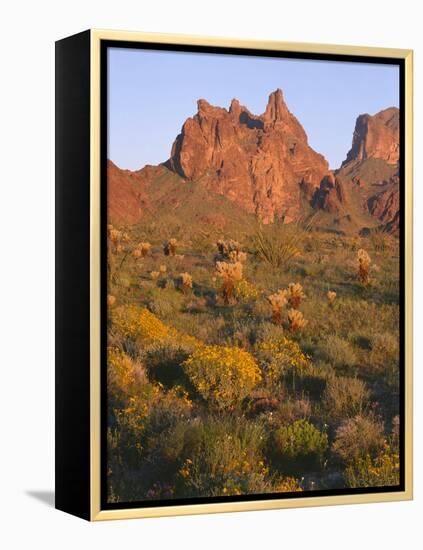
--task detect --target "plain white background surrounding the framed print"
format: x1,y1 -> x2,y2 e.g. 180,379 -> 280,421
0,0 -> 423,550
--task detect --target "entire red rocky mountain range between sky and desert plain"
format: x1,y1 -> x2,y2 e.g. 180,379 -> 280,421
108,94 -> 400,234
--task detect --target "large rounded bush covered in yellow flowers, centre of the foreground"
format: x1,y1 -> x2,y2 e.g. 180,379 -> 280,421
183,346 -> 261,409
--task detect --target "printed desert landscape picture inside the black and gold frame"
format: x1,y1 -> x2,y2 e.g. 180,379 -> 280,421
104,48 -> 402,504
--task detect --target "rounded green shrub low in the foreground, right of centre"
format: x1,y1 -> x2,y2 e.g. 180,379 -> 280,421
273,420 -> 328,472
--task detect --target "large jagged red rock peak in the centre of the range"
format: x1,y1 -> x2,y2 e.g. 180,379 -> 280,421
167,89 -> 329,223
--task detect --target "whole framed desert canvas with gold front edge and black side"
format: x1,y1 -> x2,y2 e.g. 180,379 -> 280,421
56,30 -> 412,520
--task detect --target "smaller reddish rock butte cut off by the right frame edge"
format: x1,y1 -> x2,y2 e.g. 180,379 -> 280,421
343,107 -> 399,164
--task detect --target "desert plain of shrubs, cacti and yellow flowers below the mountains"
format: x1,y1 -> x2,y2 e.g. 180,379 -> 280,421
107,220 -> 400,502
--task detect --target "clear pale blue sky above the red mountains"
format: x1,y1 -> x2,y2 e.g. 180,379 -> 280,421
108,48 -> 399,170
